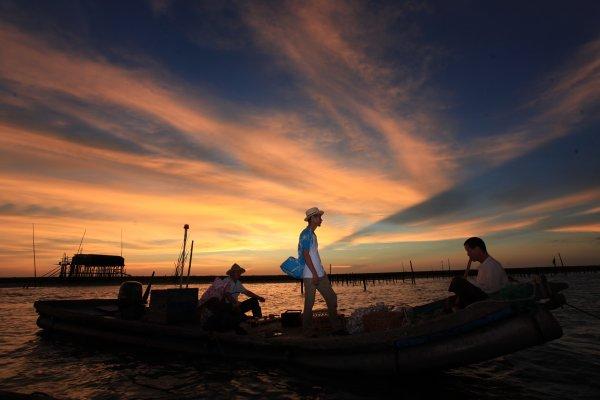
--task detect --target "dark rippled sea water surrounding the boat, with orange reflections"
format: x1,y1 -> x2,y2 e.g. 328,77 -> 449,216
0,274 -> 600,399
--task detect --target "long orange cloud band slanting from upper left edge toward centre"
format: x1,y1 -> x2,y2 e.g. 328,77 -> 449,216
0,20 -> 432,212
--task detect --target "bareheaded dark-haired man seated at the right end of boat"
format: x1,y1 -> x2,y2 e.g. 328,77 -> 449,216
448,237 -> 508,308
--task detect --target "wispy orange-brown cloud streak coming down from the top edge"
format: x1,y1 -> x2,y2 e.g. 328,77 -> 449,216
241,2 -> 456,194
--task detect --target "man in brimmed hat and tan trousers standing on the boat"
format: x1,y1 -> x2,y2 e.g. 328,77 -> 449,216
298,207 -> 345,336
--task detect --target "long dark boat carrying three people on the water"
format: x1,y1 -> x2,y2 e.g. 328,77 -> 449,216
35,283 -> 567,374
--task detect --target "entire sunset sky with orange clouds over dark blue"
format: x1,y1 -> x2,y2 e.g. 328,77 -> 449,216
0,0 -> 600,276
